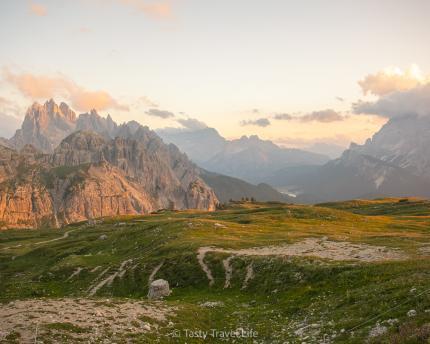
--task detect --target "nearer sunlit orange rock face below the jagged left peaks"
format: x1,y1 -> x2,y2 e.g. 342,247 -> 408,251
0,127 -> 218,228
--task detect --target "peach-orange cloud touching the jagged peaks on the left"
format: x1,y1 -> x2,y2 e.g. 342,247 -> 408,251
3,68 -> 129,111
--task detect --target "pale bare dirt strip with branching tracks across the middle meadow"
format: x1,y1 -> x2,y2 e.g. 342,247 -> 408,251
197,238 -> 406,288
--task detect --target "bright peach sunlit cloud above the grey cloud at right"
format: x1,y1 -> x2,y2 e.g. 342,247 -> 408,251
358,64 -> 428,96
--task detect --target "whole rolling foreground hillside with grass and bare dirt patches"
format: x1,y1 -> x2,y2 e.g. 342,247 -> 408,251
0,200 -> 430,344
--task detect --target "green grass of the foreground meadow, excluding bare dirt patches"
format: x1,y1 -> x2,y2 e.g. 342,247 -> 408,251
0,200 -> 430,343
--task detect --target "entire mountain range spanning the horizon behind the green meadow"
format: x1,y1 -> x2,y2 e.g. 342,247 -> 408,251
0,100 -> 430,228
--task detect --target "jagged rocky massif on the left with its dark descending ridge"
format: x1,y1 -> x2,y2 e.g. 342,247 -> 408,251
0,100 -> 288,228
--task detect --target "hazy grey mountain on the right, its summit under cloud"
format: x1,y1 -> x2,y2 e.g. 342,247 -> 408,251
268,116 -> 430,202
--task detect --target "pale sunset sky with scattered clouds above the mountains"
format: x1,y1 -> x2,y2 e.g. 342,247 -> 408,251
0,0 -> 430,147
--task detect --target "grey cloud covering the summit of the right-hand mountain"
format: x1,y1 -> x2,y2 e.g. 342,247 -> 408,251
353,83 -> 430,118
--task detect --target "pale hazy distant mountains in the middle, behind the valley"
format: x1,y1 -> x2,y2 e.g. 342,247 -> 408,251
157,128 -> 330,183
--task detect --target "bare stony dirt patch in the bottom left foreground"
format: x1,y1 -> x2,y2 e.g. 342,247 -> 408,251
0,299 -> 175,343
